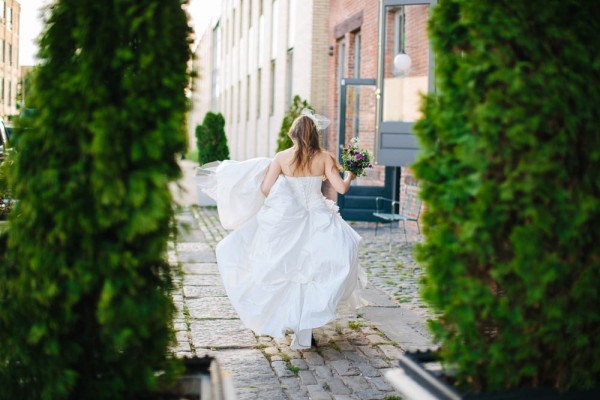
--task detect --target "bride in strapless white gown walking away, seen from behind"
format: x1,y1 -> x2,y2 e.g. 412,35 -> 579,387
199,112 -> 364,350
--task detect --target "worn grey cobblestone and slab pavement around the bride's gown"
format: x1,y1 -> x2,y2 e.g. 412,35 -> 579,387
169,207 -> 429,400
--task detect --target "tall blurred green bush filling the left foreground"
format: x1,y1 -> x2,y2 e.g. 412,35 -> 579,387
0,0 -> 190,400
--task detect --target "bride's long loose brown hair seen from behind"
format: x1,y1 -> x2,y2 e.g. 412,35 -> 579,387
288,115 -> 321,171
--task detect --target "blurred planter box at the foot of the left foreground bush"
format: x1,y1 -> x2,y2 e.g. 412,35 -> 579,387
146,356 -> 235,400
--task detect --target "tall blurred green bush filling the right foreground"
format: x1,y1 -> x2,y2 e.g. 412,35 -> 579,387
414,0 -> 600,389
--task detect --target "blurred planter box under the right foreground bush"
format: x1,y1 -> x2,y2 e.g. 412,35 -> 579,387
385,351 -> 600,400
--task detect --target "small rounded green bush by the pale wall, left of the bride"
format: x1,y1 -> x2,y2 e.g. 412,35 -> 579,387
196,111 -> 229,164
